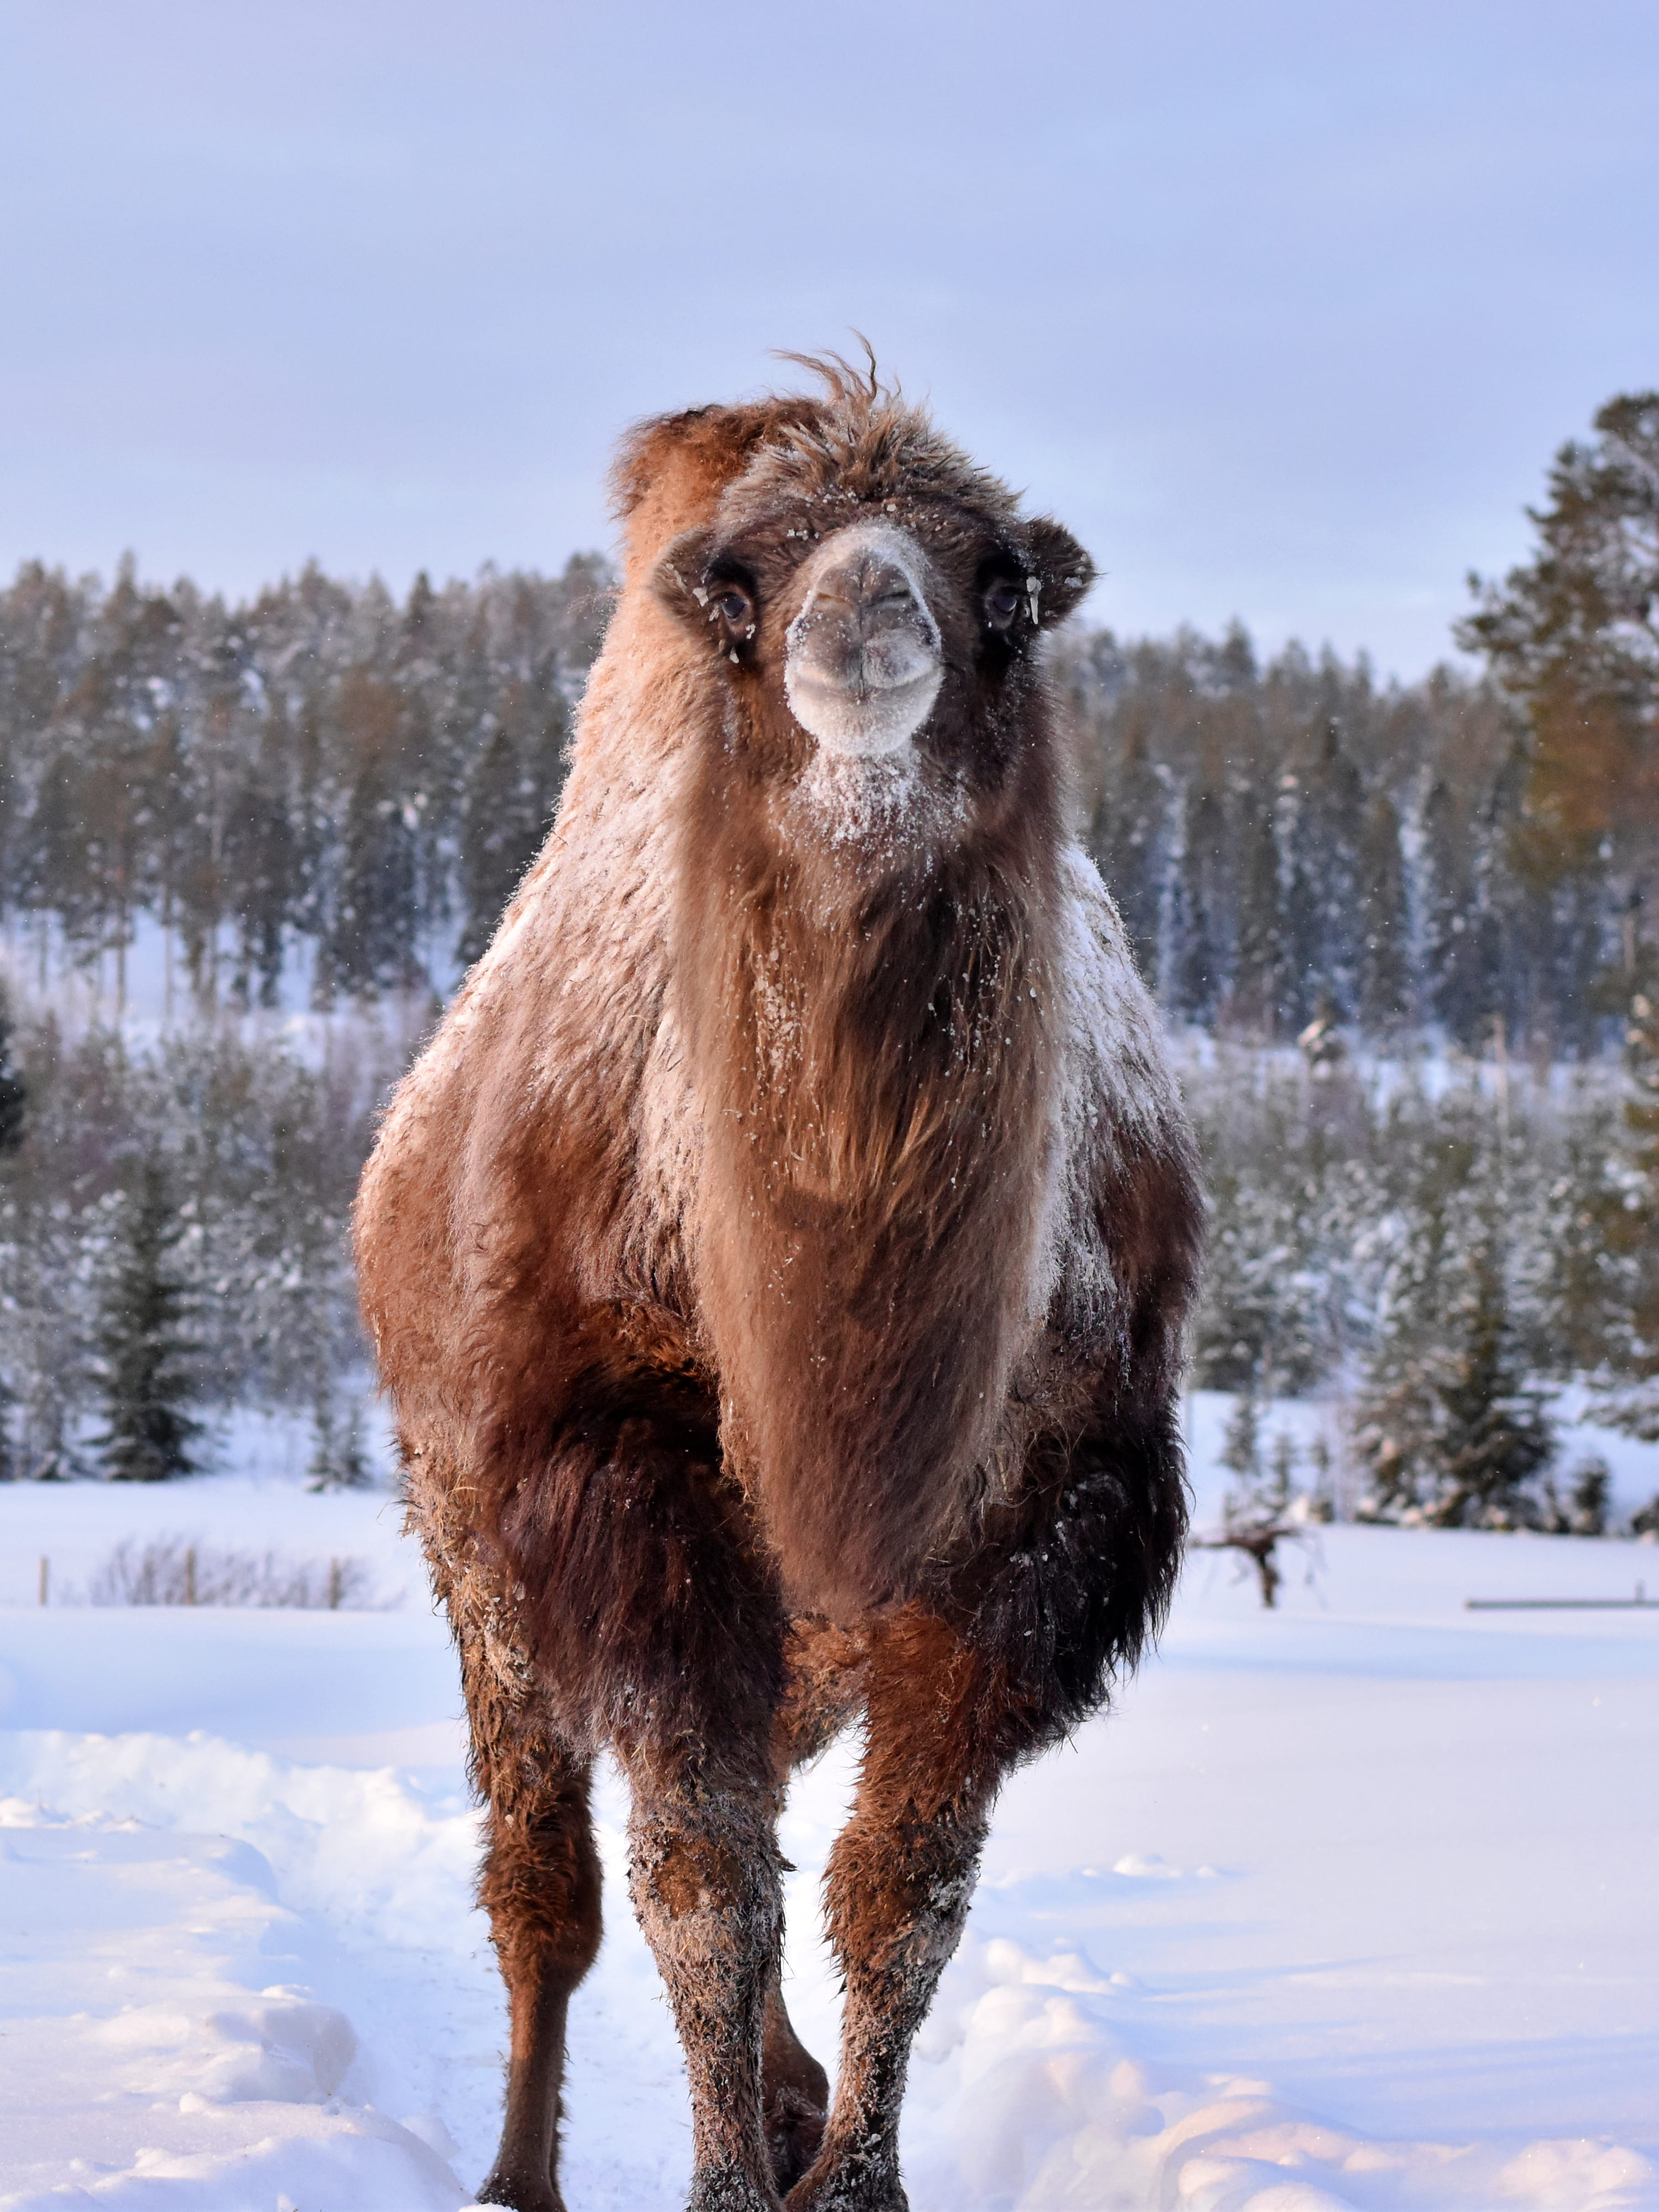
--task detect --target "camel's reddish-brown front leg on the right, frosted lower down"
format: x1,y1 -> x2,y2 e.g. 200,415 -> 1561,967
790,1613 -> 1000,2212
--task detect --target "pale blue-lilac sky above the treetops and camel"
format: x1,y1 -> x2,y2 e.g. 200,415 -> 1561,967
0,0 -> 1659,679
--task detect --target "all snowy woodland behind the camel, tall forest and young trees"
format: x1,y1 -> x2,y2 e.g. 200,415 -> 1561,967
0,394 -> 1659,1526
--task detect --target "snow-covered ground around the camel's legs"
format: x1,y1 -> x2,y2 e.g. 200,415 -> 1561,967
0,1400 -> 1659,2212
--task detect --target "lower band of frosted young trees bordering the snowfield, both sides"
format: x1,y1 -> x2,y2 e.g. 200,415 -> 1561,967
0,995 -> 1659,1526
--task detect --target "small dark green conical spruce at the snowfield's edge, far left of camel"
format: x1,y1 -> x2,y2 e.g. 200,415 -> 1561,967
95,1152 -> 201,1482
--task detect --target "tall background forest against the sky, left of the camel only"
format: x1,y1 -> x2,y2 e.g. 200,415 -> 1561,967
0,557 -> 611,1009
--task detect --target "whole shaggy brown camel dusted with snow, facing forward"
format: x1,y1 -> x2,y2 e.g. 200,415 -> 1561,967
356,356 -> 1201,2212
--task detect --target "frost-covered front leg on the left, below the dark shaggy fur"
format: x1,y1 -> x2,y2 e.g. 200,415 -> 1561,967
619,1745 -> 783,2212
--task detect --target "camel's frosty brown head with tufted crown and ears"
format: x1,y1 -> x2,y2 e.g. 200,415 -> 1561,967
653,363 -> 1095,849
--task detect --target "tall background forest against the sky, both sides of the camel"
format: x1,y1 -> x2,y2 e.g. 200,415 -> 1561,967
0,394 -> 1659,1055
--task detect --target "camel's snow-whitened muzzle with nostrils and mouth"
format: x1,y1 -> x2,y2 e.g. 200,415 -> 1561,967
783,522 -> 945,759
